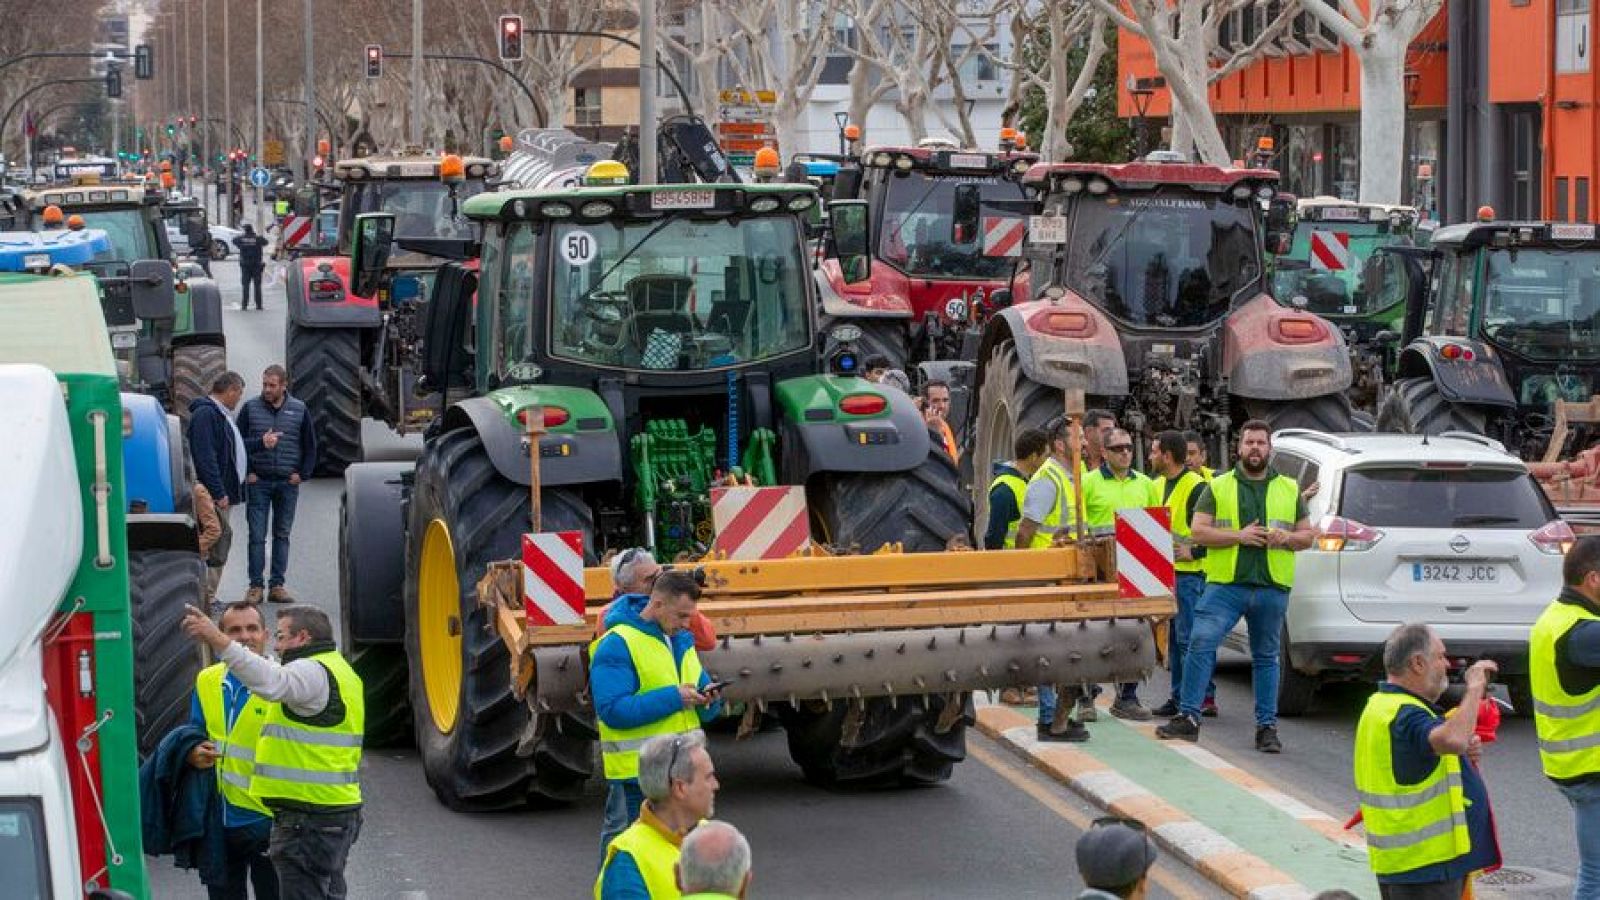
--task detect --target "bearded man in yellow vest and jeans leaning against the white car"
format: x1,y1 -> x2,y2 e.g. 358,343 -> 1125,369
1155,420 -> 1314,753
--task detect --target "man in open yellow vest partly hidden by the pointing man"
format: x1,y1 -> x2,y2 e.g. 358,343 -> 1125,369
189,602 -> 278,900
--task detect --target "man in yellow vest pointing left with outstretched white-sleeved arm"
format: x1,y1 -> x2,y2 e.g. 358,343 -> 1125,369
184,605 -> 366,900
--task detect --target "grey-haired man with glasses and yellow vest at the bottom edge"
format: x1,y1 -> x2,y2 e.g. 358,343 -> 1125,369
595,732 -> 717,900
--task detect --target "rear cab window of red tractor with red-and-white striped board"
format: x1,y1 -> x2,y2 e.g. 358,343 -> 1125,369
878,171 -> 1022,280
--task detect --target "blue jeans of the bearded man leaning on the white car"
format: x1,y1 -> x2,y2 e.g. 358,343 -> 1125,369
1178,585 -> 1290,727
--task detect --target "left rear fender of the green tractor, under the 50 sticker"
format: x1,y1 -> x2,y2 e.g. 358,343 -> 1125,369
443,384 -> 622,487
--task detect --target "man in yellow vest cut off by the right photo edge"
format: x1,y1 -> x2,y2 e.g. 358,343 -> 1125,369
1528,535 -> 1600,897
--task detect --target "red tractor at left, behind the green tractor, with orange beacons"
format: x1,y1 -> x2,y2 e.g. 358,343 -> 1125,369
285,152 -> 499,474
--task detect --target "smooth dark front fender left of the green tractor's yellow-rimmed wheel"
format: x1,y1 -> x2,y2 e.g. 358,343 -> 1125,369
339,463 -> 413,640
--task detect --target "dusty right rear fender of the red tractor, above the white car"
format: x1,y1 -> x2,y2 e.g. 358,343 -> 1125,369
1222,293 -> 1352,400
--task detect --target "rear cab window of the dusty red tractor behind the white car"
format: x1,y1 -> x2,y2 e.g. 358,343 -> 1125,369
1066,189 -> 1261,328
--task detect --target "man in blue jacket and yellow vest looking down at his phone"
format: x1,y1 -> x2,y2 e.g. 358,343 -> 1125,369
589,570 -> 722,860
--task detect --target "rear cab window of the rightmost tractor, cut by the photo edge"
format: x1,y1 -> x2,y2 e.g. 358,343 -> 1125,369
1482,250 -> 1600,360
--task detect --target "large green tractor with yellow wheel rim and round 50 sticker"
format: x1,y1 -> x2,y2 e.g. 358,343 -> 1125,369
341,175 -> 971,809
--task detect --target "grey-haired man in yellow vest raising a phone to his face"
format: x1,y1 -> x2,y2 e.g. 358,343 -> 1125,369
1355,623 -> 1501,900
